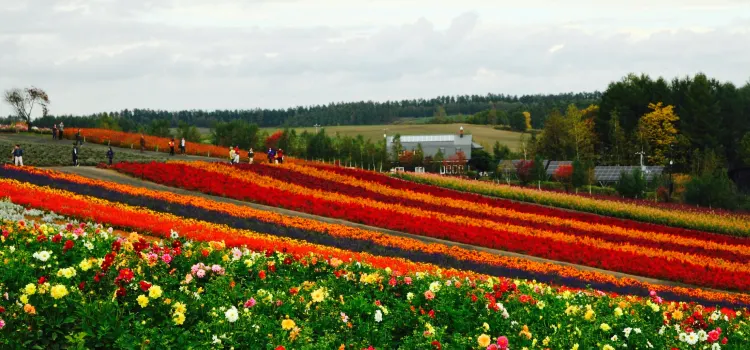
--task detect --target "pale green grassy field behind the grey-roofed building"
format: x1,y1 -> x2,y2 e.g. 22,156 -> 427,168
263,124 -> 521,150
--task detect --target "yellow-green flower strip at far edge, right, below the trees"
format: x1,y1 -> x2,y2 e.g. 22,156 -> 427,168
394,170 -> 750,237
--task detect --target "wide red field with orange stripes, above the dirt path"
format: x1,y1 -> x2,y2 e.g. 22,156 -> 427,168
104,162 -> 750,292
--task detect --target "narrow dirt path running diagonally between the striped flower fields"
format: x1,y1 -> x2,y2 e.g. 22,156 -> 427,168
54,167 -> 741,294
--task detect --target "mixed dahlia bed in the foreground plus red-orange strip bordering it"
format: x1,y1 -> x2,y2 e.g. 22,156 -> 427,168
0,200 -> 750,350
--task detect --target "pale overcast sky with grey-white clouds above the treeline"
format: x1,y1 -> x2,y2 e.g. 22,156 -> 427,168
0,0 -> 750,115
